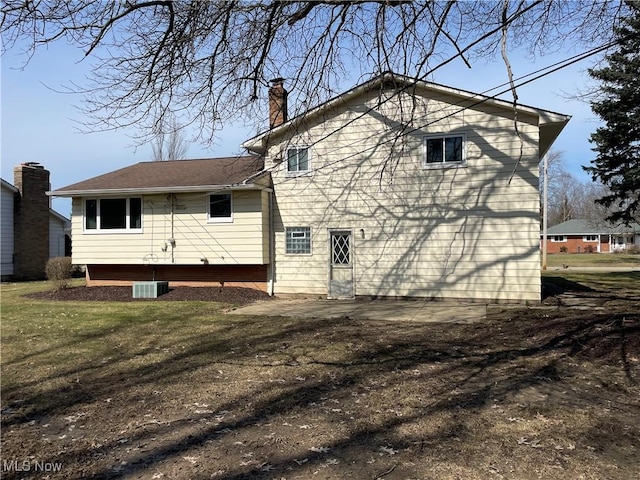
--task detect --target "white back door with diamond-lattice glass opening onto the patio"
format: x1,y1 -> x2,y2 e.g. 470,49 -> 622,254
329,230 -> 354,298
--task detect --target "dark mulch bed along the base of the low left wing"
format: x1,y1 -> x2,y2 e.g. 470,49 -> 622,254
25,287 -> 271,305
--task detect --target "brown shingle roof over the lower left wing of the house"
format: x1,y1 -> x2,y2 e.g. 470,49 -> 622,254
51,156 -> 264,196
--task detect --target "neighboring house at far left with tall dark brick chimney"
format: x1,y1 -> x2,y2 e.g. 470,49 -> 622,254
0,162 -> 71,281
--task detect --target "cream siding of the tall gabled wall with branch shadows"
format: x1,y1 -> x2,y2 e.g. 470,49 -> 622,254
267,87 -> 541,301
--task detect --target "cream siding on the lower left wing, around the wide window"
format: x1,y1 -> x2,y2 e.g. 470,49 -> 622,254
72,190 -> 268,265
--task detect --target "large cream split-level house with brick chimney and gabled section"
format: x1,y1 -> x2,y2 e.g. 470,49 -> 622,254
51,74 -> 569,302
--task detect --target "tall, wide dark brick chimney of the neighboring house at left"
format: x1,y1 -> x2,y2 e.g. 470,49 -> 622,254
13,162 -> 51,280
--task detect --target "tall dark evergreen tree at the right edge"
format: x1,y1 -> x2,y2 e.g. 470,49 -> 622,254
585,1 -> 640,224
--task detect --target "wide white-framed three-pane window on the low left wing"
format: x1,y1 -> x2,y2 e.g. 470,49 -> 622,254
84,198 -> 142,231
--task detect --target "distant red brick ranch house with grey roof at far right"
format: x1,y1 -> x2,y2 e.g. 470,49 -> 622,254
547,219 -> 640,253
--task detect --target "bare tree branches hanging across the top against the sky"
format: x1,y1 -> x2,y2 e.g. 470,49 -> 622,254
0,0 -> 627,143
